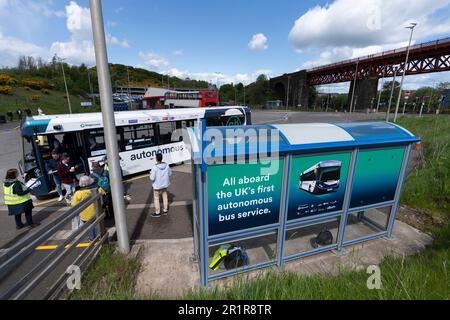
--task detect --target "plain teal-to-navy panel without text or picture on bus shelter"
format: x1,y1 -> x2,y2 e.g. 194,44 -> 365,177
350,147 -> 405,208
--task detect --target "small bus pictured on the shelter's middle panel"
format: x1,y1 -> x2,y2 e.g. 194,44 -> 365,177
299,160 -> 342,195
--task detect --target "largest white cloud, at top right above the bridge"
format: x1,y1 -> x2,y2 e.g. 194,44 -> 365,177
289,0 -> 450,68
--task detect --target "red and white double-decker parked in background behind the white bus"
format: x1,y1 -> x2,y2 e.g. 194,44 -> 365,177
144,88 -> 219,109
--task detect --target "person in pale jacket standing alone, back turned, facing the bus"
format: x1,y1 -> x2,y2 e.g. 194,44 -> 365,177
150,153 -> 172,218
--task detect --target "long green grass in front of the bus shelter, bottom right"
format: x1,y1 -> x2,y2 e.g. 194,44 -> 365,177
184,225 -> 450,300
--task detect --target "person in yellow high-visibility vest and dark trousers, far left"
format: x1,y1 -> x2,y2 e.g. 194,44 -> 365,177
3,169 -> 39,230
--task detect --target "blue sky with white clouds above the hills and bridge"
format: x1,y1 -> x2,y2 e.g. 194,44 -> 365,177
0,0 -> 450,91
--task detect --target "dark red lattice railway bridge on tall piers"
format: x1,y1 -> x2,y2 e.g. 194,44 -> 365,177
270,38 -> 450,109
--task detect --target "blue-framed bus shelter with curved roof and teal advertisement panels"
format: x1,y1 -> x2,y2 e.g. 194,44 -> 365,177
192,122 -> 420,286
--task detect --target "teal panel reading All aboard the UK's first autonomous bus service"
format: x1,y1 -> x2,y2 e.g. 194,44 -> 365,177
207,160 -> 284,236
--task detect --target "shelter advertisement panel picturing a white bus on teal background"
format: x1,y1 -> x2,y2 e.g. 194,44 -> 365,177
288,152 -> 351,221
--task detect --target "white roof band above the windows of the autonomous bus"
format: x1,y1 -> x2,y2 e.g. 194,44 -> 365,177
22,107 -> 248,137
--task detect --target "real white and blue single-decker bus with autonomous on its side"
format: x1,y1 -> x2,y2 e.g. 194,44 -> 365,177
19,107 -> 251,197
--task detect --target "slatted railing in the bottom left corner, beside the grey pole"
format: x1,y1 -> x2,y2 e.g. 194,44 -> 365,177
0,192 -> 107,300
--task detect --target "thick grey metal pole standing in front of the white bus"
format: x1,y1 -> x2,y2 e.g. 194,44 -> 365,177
89,0 -> 130,254
